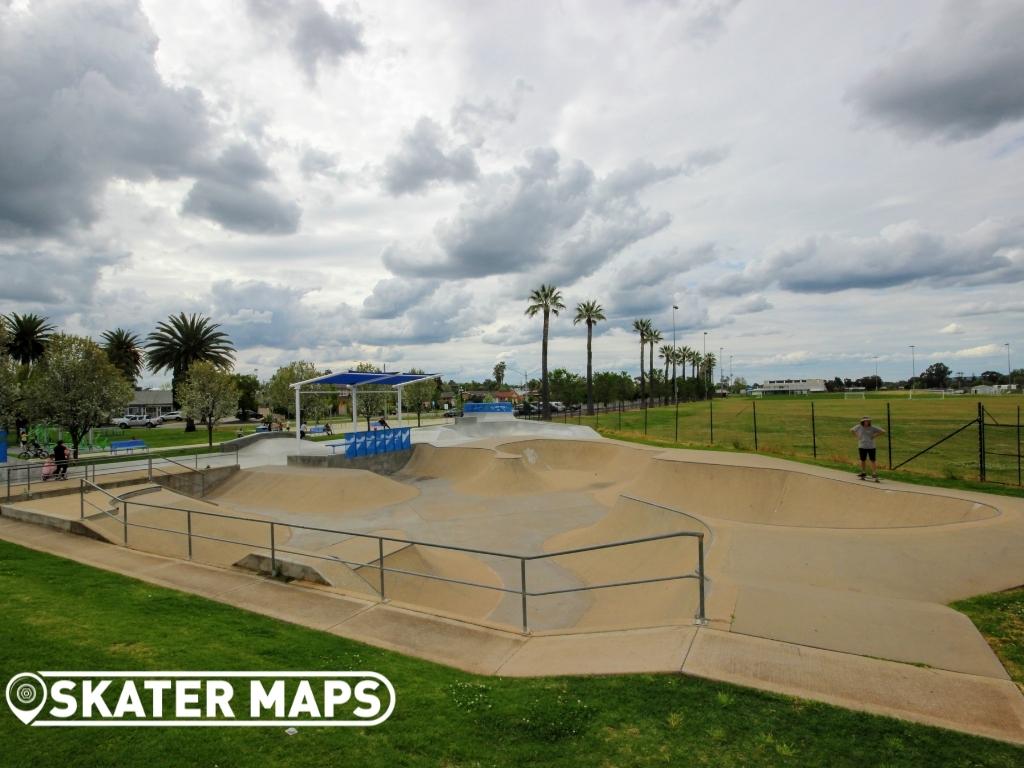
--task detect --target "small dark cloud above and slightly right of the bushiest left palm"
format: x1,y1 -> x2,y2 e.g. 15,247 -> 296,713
181,144 -> 302,234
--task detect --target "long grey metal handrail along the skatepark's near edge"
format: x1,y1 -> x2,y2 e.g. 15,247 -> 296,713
80,479 -> 707,634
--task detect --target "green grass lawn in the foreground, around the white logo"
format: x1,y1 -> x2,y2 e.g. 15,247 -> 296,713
0,542 -> 1024,768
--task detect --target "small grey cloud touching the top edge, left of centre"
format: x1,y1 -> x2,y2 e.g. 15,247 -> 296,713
248,0 -> 365,86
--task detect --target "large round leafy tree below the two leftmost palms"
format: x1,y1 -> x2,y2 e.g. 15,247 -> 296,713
28,334 -> 132,457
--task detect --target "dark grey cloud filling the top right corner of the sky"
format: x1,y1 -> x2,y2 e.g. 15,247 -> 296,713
849,1 -> 1024,141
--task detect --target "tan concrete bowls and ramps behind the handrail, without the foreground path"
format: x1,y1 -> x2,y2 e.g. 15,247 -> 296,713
70,437 -> 1024,678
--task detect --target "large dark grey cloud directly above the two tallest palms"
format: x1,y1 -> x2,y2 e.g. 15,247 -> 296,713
383,147 -> 677,283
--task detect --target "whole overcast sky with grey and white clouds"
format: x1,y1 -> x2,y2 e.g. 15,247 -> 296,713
0,0 -> 1024,383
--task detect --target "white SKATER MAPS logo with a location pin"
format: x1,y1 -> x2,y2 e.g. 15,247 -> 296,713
5,672 -> 395,728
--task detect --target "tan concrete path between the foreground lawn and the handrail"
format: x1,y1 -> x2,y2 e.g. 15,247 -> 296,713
0,517 -> 1024,744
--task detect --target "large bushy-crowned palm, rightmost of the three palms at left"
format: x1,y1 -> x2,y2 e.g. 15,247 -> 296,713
145,312 -> 234,432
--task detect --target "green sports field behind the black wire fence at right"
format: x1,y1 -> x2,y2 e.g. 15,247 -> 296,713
569,393 -> 1024,485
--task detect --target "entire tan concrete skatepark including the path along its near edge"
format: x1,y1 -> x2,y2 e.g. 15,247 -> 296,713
0,418 -> 1024,742
